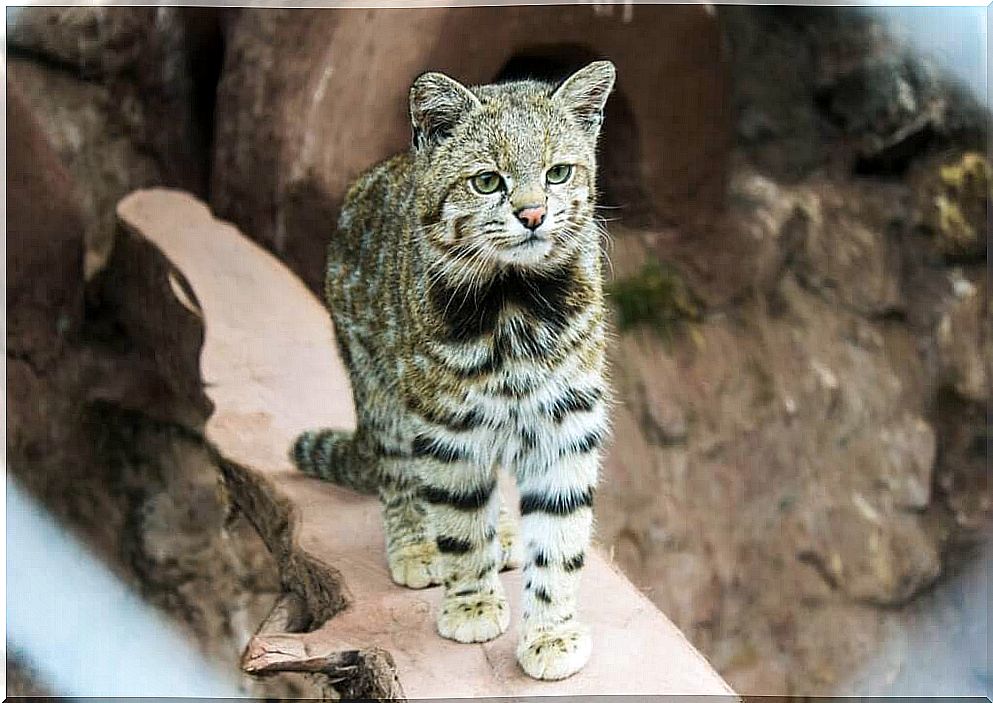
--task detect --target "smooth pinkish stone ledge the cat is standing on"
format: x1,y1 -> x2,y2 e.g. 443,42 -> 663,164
118,191 -> 732,698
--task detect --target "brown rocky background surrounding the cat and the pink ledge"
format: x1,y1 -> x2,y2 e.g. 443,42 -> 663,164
7,5 -> 993,696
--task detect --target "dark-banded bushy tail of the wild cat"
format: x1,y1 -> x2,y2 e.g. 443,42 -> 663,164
290,429 -> 380,494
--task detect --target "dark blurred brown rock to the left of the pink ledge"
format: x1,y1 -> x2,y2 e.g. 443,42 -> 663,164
7,7 -> 326,697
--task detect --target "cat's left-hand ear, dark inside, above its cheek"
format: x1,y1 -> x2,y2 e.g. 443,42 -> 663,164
410,72 -> 480,149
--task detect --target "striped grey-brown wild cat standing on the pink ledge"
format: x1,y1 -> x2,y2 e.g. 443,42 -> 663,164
291,61 -> 615,679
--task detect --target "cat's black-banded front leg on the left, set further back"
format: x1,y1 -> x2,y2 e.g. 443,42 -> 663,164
419,452 -> 510,642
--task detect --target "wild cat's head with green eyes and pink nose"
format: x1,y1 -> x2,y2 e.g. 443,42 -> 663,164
410,61 -> 615,279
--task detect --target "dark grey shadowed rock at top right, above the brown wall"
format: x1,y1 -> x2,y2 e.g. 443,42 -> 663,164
717,6 -> 988,182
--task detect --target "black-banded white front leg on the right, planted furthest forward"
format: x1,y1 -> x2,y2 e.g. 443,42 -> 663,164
517,446 -> 601,680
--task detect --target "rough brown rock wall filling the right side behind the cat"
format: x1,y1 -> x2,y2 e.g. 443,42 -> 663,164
599,8 -> 993,695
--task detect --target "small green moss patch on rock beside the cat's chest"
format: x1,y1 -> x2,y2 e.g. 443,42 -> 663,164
607,261 -> 701,340
